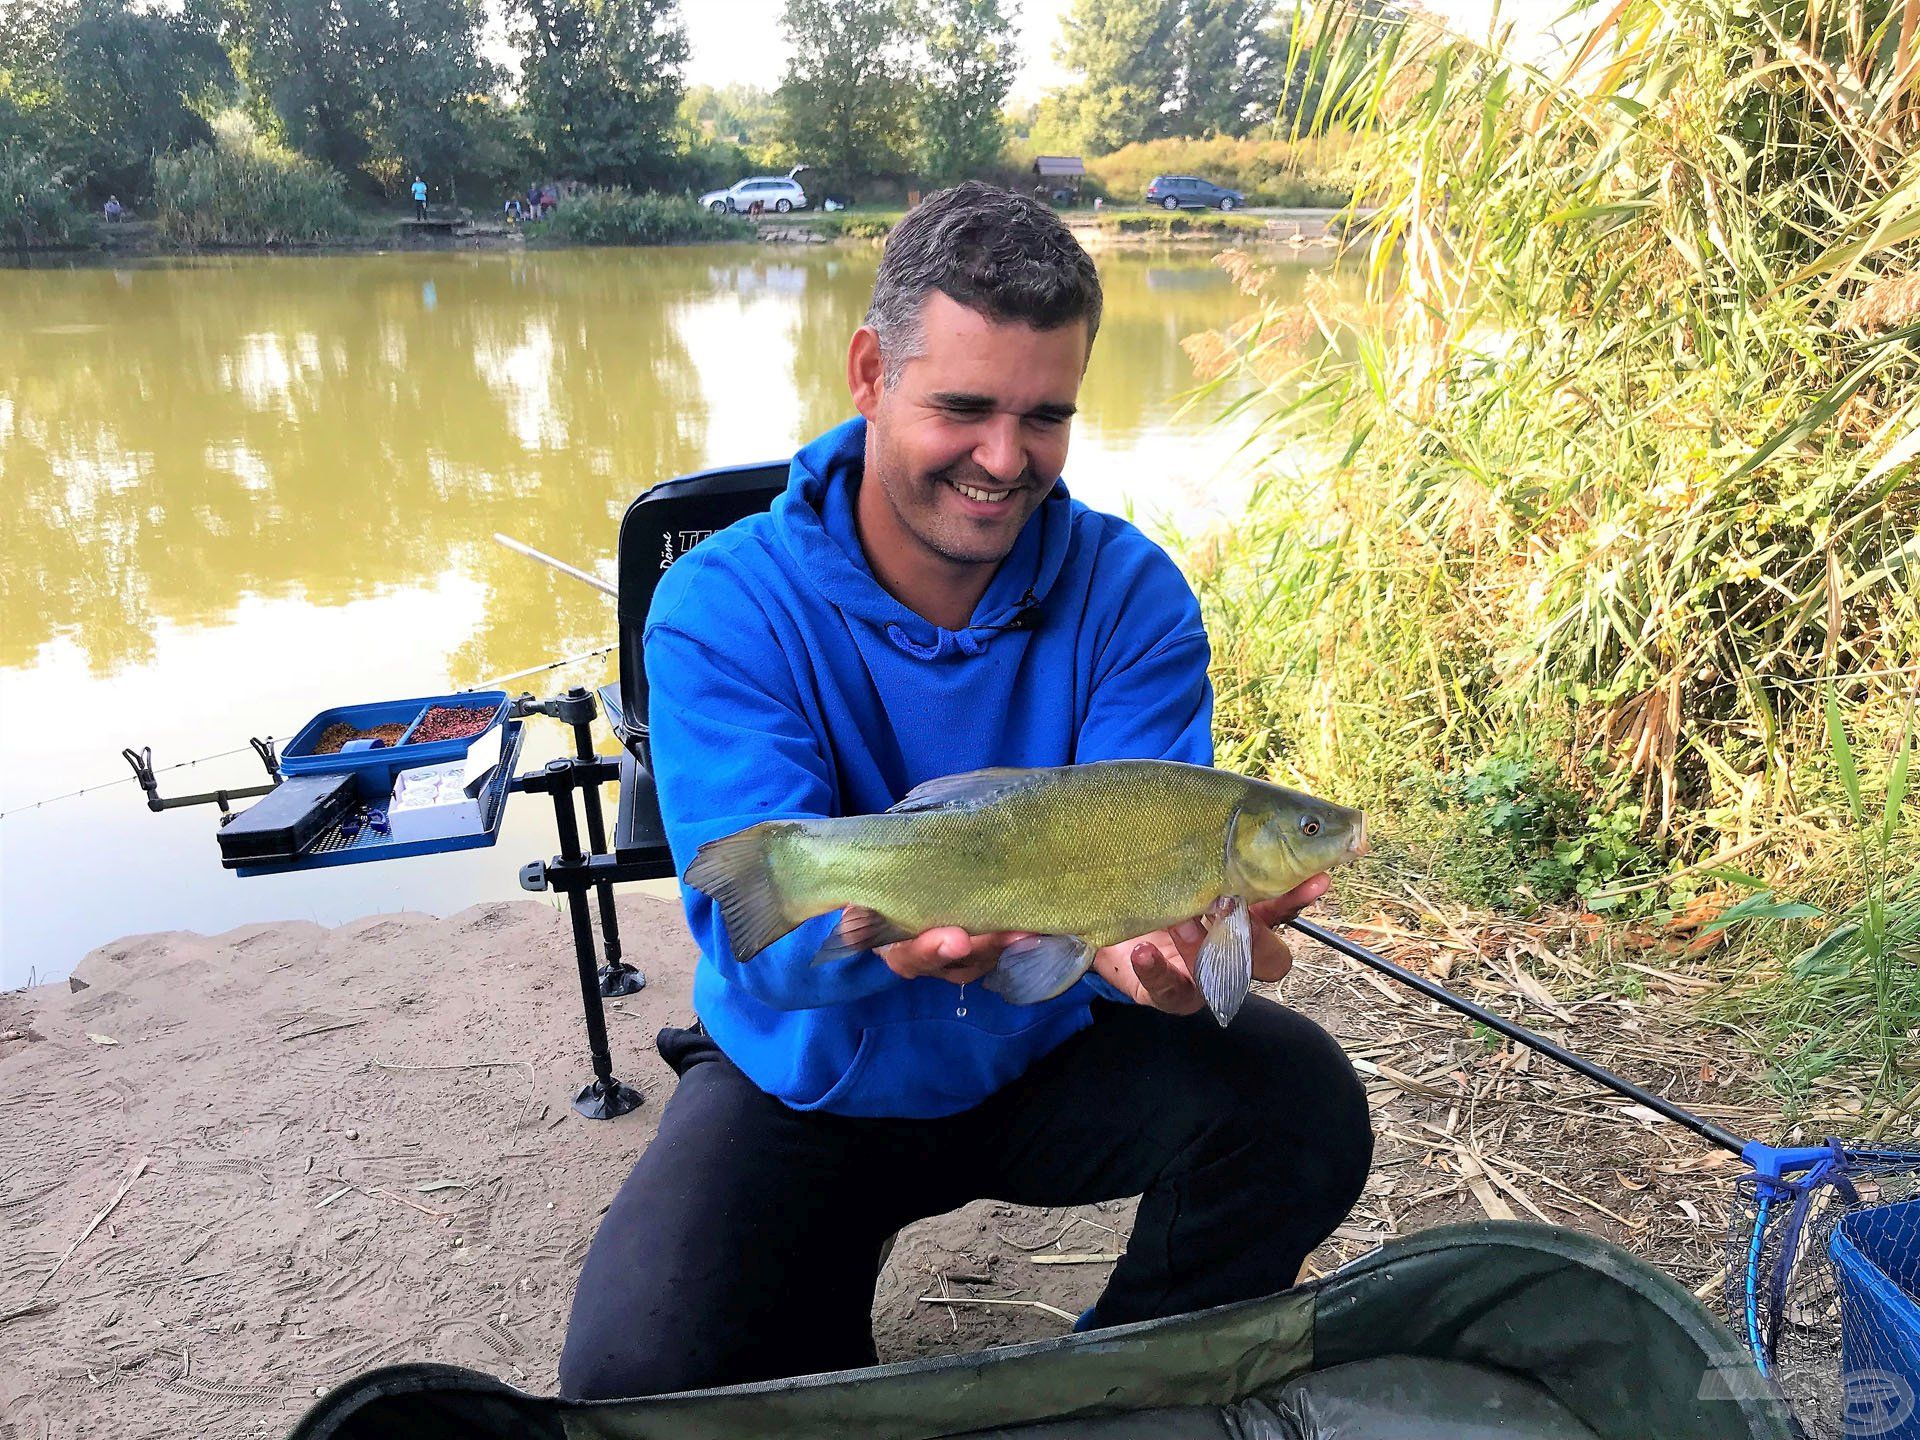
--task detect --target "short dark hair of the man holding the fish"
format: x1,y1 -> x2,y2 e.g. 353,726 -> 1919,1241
866,180 -> 1100,380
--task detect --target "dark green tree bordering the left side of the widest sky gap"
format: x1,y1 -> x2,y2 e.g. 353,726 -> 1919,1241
513,0 -> 687,184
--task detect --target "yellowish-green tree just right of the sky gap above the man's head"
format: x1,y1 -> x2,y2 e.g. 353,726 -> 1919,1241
1043,0 -> 1183,154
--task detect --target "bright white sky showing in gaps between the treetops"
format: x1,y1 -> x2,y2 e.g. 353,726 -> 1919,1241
680,0 -> 1567,104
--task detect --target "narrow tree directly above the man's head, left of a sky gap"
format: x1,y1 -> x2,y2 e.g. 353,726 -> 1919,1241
918,0 -> 1020,180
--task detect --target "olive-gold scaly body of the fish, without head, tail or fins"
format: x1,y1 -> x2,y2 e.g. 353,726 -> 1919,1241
774,764 -> 1246,945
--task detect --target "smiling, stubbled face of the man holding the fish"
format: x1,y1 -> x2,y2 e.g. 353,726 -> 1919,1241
849,290 -> 1087,564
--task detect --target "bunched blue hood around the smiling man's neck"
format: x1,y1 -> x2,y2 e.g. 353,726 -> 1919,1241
772,417 -> 1073,660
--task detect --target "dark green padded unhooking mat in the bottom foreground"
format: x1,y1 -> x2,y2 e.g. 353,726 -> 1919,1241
292,1223 -> 1795,1440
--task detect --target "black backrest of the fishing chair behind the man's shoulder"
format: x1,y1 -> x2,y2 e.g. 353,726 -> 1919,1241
618,461 -> 787,745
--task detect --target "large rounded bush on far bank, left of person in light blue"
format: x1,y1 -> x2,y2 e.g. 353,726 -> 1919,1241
154,113 -> 359,246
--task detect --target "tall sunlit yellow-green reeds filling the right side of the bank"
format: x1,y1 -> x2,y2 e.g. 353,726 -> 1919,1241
1192,0 -> 1920,1083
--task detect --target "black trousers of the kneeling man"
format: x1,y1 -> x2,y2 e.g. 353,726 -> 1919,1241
561,996 -> 1373,1400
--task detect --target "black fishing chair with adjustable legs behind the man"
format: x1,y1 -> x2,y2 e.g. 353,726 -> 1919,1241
515,461 -> 787,1119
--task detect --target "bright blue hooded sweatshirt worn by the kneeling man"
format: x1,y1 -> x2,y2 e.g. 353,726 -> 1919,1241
645,419 -> 1213,1116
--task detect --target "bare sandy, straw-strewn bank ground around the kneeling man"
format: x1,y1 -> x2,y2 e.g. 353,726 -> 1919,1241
0,897 -> 1804,1440
